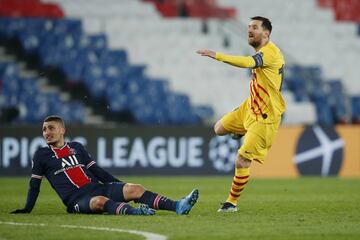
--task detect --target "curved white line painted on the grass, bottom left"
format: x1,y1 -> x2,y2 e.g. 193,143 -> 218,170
0,221 -> 167,240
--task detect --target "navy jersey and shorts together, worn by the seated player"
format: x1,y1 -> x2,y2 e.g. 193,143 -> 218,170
25,142 -> 124,212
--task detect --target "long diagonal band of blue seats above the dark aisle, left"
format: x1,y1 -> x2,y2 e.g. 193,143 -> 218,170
1,1 -> 212,125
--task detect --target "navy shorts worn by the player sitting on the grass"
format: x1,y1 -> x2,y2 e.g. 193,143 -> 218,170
67,182 -> 126,214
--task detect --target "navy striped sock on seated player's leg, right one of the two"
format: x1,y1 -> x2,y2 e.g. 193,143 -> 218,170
137,191 -> 176,211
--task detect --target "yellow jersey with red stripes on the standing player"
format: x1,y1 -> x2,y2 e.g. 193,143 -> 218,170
216,41 -> 285,123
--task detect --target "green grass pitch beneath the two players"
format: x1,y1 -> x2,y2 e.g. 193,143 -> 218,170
0,177 -> 360,240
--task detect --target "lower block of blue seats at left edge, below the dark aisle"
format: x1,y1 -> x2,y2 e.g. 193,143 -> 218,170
0,46 -> 86,123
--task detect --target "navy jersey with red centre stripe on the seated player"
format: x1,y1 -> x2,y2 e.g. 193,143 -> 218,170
30,142 -> 119,205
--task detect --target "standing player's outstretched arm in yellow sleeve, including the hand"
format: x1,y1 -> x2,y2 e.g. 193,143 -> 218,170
196,49 -> 261,68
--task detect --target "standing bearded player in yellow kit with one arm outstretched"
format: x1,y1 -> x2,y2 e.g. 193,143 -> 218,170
197,16 -> 285,212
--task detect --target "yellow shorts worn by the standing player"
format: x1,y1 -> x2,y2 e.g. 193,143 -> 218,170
221,101 -> 280,163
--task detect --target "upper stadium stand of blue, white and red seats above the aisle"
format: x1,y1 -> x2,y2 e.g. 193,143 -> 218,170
0,0 -> 360,124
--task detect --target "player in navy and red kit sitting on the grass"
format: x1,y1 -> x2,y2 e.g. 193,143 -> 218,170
12,116 -> 199,215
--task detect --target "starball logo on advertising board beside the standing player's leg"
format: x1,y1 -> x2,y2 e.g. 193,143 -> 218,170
209,135 -> 239,173
